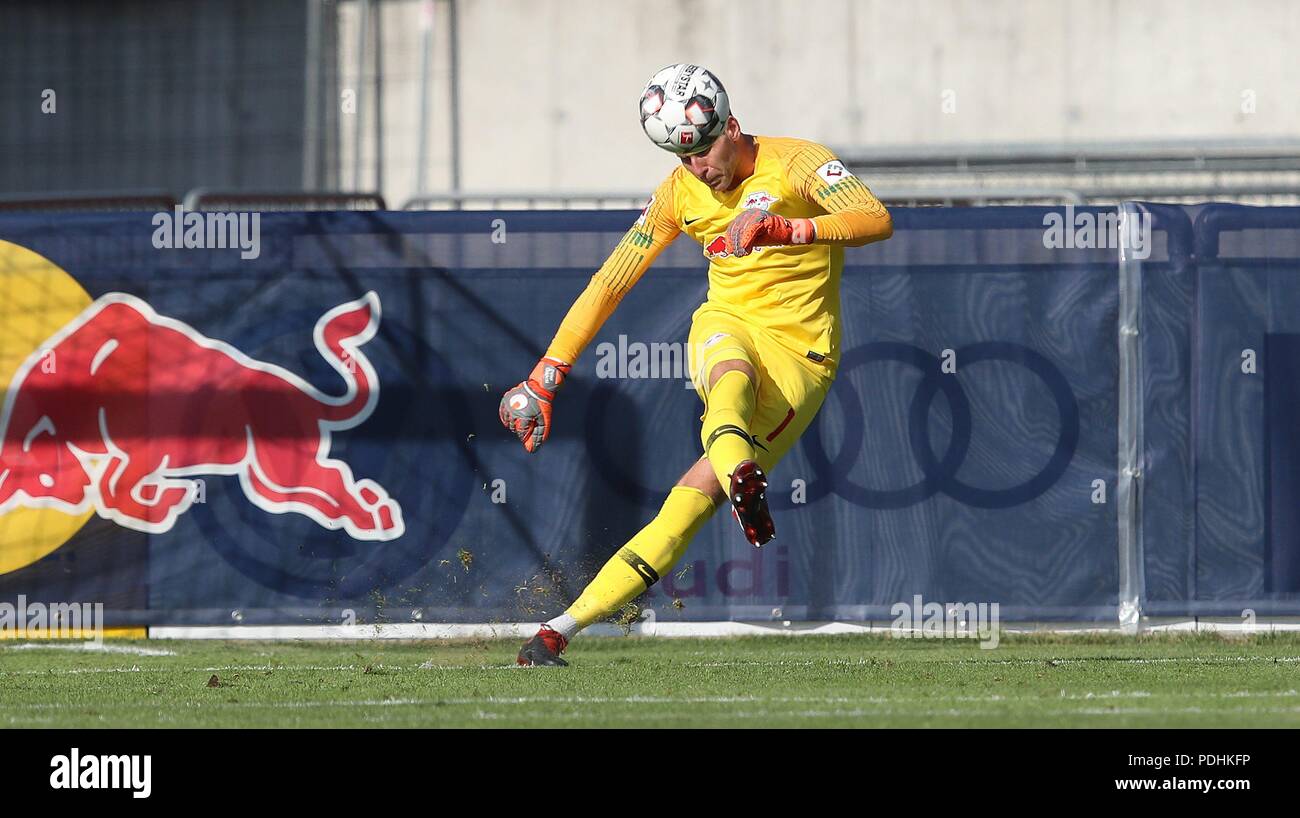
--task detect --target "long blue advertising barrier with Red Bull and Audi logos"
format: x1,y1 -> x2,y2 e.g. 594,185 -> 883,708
0,203 -> 1300,632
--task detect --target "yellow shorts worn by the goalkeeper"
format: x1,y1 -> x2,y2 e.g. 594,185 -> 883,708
686,302 -> 835,472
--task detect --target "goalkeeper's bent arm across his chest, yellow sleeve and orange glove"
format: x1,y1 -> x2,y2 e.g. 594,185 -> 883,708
727,143 -> 893,256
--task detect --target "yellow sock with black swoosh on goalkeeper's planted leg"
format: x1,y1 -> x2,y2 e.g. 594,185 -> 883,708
564,485 -> 715,628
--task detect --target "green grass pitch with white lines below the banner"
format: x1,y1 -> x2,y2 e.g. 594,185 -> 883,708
0,633 -> 1300,728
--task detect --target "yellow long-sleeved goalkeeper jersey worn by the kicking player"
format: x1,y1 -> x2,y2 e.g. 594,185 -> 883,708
547,137 -> 892,367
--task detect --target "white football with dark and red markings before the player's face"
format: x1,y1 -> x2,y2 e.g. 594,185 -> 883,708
641,64 -> 731,156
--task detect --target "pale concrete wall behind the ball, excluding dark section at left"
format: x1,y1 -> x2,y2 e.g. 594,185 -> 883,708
339,0 -> 1300,203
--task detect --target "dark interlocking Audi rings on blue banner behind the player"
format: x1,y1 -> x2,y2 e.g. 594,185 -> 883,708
586,341 -> 1079,508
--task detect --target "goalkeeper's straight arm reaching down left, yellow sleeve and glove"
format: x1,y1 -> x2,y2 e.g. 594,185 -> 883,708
499,177 -> 681,451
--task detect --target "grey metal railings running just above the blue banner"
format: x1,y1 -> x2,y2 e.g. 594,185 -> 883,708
0,140 -> 1300,211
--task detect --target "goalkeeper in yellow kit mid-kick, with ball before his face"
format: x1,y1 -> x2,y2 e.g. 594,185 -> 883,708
501,65 -> 893,665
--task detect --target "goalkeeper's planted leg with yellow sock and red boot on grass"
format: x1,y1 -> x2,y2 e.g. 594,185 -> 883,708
517,481 -> 716,666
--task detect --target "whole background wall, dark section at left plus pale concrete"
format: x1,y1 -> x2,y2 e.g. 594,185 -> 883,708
0,0 -> 1300,205
